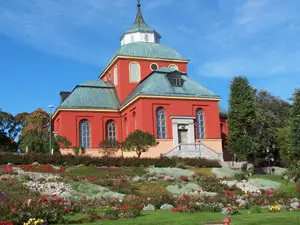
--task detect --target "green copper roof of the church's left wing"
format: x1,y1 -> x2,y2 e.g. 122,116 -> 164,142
59,81 -> 120,109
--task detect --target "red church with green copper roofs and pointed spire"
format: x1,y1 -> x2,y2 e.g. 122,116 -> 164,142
52,3 -> 227,160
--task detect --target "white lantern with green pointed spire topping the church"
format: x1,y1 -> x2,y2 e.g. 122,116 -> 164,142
121,0 -> 161,45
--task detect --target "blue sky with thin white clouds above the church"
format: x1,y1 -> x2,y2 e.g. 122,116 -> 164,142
0,0 -> 300,114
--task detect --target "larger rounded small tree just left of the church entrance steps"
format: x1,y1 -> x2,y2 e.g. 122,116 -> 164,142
124,130 -> 158,158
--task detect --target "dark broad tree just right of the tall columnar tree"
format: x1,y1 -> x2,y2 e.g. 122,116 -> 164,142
255,90 -> 290,163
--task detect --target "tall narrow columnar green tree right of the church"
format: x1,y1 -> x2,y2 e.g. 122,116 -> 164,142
228,76 -> 259,161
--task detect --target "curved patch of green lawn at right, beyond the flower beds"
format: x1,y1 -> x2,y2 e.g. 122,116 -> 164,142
251,174 -> 300,195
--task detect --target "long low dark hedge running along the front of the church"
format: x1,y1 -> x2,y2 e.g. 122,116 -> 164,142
0,153 -> 220,168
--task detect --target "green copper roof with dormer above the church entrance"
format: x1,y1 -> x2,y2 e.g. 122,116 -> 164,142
122,68 -> 220,105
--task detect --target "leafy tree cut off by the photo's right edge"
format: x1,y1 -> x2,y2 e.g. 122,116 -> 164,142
291,89 -> 300,159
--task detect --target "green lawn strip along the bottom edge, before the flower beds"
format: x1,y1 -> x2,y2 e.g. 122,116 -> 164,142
67,211 -> 300,225
